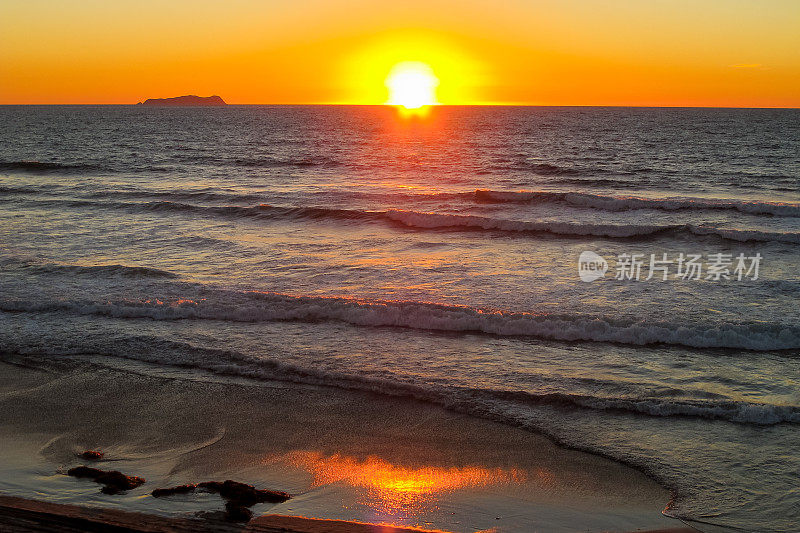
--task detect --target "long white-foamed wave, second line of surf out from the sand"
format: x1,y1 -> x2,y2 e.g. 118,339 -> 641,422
0,291 -> 800,351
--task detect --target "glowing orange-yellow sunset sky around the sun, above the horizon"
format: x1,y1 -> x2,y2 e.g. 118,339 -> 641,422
0,0 -> 800,107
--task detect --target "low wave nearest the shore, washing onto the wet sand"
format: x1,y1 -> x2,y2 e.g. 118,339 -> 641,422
3,335 -> 800,425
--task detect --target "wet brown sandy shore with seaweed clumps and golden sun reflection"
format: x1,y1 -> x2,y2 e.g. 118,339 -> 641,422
0,357 -> 681,532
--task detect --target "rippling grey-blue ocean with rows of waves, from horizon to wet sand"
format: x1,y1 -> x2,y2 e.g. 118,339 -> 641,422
0,106 -> 800,532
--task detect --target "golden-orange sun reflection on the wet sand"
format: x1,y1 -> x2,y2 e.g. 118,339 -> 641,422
268,451 -> 539,519
